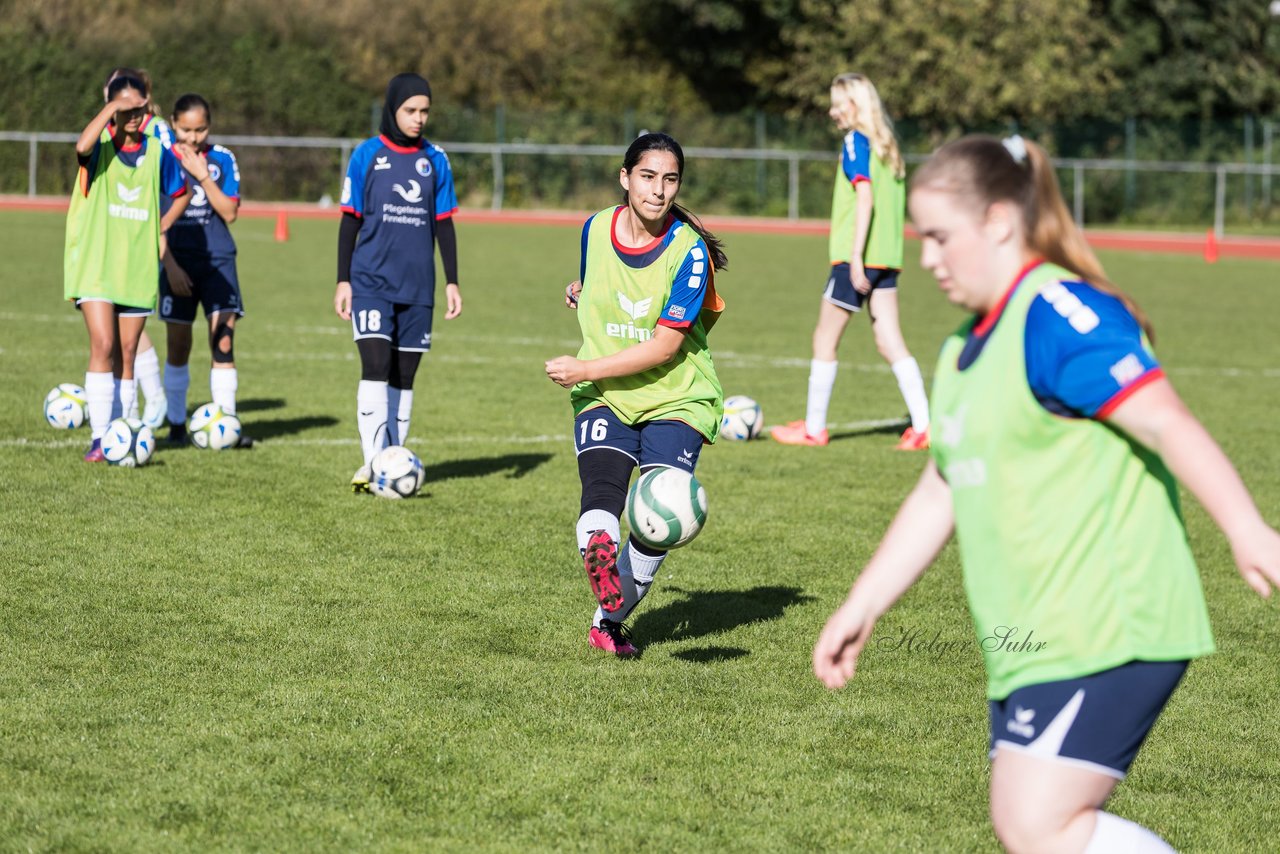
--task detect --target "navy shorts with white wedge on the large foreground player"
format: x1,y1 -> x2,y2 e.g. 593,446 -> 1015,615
991,661 -> 1187,780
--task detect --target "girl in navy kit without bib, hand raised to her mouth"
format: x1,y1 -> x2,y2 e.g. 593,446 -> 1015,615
160,93 -> 253,448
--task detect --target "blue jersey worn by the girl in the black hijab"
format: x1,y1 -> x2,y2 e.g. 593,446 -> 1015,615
342,136 -> 458,306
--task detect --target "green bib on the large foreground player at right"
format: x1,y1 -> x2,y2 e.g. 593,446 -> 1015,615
929,264 -> 1213,699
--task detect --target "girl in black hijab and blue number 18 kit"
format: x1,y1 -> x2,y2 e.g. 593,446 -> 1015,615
333,74 -> 462,493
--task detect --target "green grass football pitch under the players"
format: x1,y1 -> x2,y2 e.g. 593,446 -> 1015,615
0,213 -> 1280,851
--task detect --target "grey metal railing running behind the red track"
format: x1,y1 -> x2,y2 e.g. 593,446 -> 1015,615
0,131 -> 1280,237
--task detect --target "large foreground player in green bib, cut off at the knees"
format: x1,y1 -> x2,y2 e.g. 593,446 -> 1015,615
813,137 -> 1280,851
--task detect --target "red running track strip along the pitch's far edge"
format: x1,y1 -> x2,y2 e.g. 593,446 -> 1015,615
0,195 -> 1280,261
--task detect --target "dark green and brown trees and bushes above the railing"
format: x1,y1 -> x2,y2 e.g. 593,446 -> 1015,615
0,0 -> 1280,136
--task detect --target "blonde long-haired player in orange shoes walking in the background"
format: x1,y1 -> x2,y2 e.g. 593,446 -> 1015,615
771,73 -> 929,451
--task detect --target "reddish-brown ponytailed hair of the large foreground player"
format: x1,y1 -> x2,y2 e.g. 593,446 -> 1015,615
911,136 -> 1156,341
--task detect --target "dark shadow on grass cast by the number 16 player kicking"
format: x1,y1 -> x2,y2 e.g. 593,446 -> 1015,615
632,586 -> 814,647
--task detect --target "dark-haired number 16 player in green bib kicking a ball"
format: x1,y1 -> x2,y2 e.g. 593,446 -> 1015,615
547,133 -> 727,657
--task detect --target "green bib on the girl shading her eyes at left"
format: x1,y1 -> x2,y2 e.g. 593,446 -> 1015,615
63,132 -> 161,309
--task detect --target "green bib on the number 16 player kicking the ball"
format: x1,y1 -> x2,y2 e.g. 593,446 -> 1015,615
570,207 -> 724,442
